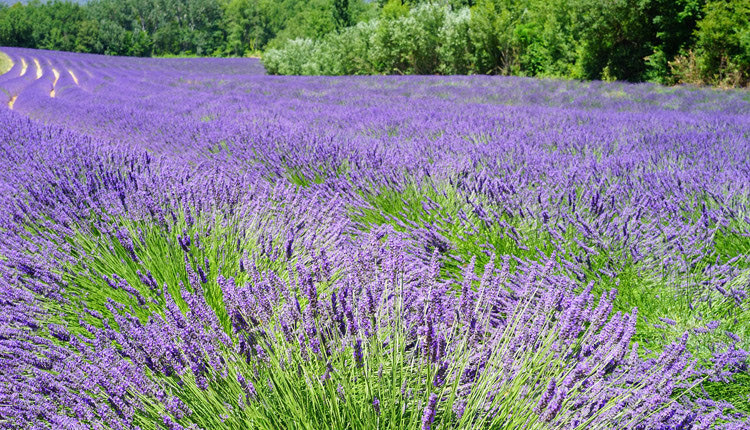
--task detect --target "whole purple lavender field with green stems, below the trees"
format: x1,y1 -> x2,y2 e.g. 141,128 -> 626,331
0,48 -> 750,430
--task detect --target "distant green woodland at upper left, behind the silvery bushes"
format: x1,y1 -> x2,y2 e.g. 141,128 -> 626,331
0,0 -> 375,56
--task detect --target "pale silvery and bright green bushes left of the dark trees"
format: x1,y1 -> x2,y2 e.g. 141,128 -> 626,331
264,0 -> 561,75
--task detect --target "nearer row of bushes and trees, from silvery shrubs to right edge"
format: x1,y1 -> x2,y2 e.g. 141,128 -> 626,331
266,0 -> 750,86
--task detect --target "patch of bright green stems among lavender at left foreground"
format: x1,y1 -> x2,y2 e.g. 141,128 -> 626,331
42,208 -> 293,340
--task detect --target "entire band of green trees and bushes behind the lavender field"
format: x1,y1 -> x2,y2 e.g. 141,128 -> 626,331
0,0 -> 750,86
